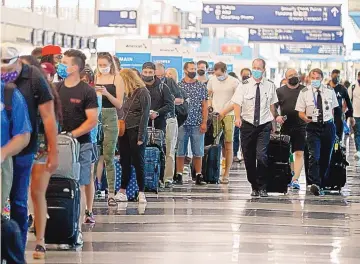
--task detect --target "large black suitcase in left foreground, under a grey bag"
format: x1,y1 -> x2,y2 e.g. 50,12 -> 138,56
45,175 -> 81,246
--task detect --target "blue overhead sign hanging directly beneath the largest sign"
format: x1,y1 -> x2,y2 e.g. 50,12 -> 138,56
249,28 -> 344,45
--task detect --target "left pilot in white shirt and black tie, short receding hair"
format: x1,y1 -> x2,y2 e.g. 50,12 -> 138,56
232,59 -> 278,197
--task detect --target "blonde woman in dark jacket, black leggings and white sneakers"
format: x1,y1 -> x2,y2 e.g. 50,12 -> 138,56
116,69 -> 151,203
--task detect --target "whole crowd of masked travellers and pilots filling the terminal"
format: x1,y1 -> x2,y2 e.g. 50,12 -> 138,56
0,44 -> 360,259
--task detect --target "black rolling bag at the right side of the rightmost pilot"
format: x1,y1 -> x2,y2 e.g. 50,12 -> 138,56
324,141 -> 349,192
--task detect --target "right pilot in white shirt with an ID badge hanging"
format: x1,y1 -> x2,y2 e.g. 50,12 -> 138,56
295,69 -> 339,196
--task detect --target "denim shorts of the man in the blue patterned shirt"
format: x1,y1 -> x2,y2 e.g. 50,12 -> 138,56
177,126 -> 205,157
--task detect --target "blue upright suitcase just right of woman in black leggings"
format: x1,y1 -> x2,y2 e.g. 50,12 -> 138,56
145,147 -> 161,193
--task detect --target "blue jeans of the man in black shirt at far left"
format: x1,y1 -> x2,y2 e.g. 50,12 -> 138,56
10,153 -> 35,252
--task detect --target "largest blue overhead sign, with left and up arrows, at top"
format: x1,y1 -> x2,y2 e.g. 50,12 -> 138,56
202,3 -> 341,29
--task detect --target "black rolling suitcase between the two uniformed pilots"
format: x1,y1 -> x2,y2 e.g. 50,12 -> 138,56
266,134 -> 292,193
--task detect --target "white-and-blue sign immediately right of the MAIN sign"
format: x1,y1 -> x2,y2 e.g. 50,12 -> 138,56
151,45 -> 183,76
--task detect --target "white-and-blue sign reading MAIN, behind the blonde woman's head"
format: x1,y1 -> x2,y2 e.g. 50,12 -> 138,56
115,39 -> 151,72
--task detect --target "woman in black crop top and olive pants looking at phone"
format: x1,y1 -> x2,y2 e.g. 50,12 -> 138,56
95,52 -> 124,205
